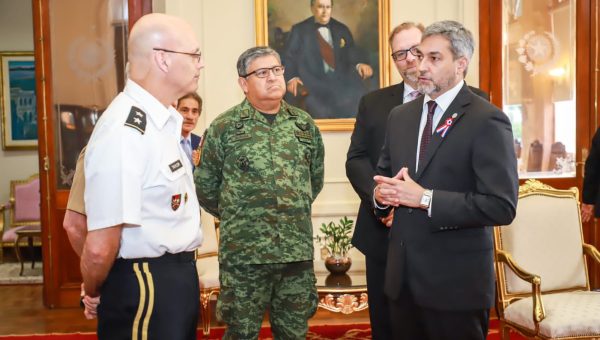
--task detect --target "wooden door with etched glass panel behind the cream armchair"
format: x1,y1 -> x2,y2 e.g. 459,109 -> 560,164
479,0 -> 600,287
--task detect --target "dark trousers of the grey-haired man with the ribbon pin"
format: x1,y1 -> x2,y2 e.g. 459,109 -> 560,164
390,289 -> 489,340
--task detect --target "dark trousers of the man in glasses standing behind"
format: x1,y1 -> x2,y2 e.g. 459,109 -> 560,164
365,256 -> 392,340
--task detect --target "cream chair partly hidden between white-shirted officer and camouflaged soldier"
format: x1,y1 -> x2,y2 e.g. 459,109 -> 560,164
196,218 -> 221,336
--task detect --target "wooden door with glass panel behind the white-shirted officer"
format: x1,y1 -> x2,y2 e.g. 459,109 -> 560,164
32,0 -> 151,308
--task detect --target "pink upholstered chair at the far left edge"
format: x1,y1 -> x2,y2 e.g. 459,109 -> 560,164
0,174 -> 41,264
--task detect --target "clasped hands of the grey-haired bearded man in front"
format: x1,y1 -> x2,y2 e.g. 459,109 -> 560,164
373,168 -> 425,208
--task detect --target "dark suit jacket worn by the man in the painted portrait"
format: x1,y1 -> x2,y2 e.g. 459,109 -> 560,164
282,17 -> 368,118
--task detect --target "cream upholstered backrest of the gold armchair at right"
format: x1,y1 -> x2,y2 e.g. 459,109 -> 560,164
500,195 -> 586,293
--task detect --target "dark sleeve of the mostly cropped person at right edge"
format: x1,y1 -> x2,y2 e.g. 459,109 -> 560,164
581,128 -> 600,217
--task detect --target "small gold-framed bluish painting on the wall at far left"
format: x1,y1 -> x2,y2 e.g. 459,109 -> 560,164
0,52 -> 38,150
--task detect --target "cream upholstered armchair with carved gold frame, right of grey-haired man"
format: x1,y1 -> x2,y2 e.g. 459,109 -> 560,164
494,180 -> 600,339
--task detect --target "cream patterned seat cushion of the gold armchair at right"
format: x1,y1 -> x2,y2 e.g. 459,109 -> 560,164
504,291 -> 600,338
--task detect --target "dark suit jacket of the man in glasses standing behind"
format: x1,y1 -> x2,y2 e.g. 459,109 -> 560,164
346,82 -> 489,262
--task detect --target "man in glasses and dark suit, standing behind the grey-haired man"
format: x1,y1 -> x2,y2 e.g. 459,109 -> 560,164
346,22 -> 488,340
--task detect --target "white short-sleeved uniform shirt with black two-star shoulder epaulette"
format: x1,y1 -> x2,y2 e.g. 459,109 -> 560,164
85,80 -> 202,259
